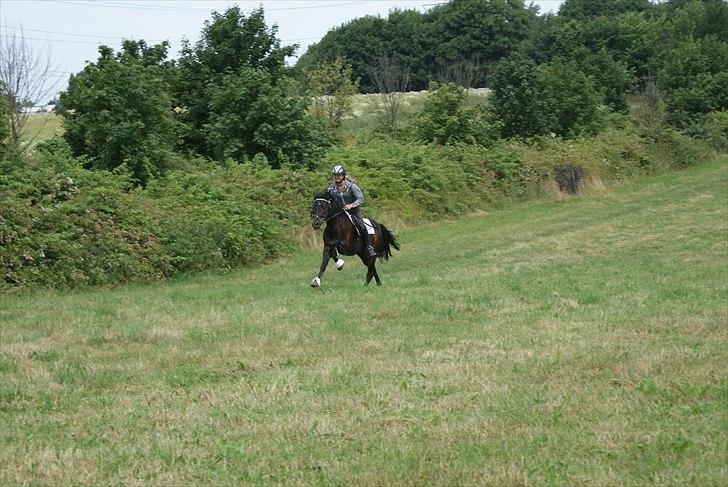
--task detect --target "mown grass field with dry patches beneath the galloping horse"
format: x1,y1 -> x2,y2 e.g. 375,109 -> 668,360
0,158 -> 728,485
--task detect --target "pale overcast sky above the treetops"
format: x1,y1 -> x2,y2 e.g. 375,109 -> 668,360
0,0 -> 563,103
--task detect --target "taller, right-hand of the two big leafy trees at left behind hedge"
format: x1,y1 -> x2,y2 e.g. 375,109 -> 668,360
172,7 -> 327,166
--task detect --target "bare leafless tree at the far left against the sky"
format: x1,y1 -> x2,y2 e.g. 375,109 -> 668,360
0,27 -> 60,144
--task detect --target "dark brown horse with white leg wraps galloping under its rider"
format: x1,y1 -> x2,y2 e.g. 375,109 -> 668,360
311,191 -> 399,287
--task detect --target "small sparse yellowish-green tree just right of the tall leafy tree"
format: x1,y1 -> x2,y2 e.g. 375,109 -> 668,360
306,57 -> 359,128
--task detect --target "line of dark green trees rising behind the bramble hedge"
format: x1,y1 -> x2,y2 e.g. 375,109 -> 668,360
0,0 -> 728,185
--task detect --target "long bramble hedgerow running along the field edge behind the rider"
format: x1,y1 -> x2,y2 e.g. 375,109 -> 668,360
0,120 -> 710,292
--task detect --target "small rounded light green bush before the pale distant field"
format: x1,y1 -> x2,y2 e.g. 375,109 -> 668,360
415,83 -> 498,145
